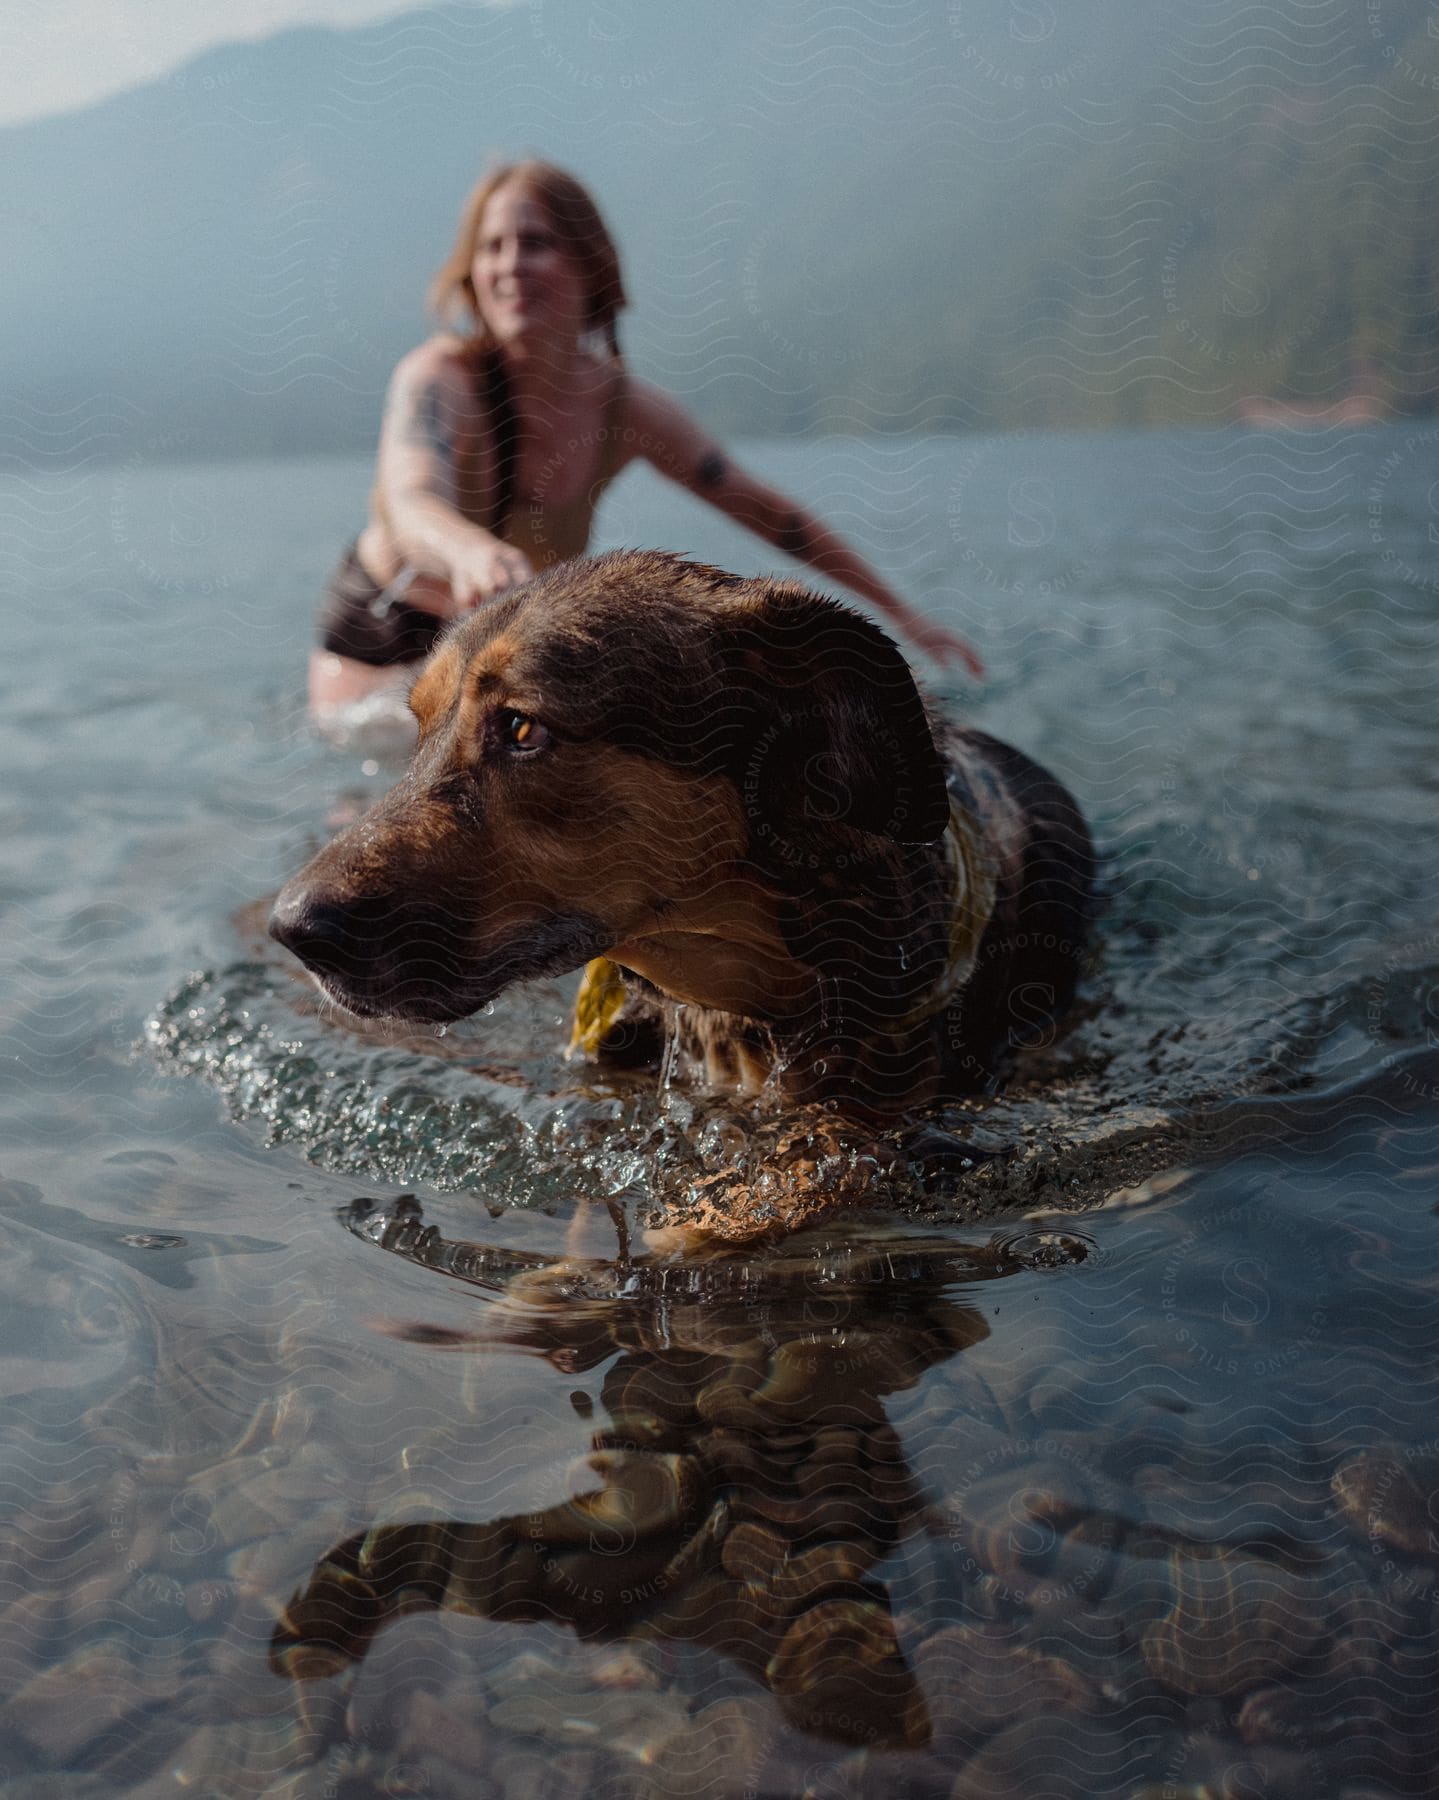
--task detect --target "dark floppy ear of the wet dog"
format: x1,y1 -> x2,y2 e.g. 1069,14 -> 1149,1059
720,581 -> 949,844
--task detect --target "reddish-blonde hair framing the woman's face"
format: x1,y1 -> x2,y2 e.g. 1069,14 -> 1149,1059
430,162 -> 629,356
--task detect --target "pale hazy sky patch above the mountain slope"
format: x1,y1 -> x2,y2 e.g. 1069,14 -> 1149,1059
0,0 -> 500,124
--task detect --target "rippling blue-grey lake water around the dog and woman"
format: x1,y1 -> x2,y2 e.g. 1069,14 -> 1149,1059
0,425 -> 1439,1796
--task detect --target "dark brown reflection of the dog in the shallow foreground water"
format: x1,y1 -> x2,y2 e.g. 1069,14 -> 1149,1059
270,1208 -> 1010,1746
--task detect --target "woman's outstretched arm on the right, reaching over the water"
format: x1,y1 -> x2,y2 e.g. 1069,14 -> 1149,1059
629,382 -> 983,677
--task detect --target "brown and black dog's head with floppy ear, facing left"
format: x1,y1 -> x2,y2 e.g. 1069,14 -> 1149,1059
270,551 -> 947,1021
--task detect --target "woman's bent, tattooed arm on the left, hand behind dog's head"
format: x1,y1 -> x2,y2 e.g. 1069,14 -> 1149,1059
375,338 -> 533,616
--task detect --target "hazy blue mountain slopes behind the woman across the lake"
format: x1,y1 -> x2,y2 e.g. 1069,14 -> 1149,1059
0,0 -> 1439,463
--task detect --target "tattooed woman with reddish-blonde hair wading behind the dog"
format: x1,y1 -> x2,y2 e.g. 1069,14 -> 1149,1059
310,162 -> 982,720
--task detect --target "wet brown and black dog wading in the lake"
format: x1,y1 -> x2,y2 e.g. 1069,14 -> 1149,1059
270,551 -> 1093,1121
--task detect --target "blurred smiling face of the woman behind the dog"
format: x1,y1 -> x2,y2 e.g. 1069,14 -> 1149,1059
470,182 -> 587,347
